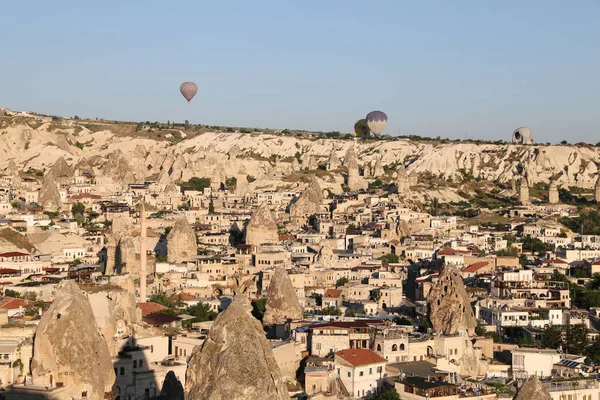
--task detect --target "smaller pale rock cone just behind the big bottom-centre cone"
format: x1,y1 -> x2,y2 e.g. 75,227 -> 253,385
263,268 -> 303,325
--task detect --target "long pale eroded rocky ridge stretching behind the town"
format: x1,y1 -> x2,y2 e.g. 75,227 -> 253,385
0,115 -> 600,194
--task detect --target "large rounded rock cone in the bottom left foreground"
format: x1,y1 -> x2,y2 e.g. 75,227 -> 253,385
31,280 -> 115,400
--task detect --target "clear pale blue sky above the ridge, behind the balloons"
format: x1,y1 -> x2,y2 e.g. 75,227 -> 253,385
0,0 -> 600,143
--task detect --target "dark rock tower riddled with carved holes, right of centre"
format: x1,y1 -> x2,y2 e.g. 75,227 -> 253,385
427,264 -> 477,335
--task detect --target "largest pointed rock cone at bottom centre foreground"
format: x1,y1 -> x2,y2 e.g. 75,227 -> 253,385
186,296 -> 290,400
